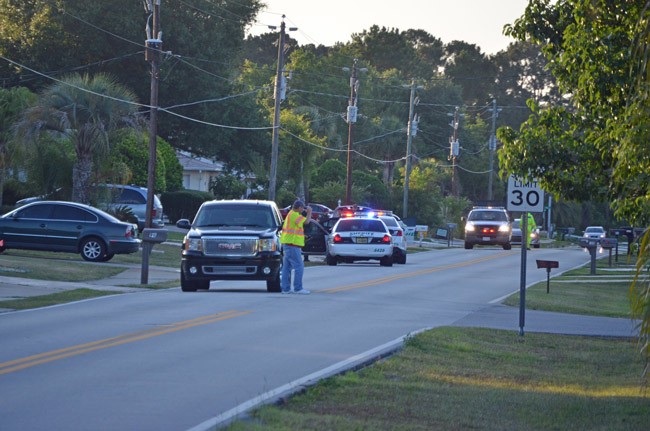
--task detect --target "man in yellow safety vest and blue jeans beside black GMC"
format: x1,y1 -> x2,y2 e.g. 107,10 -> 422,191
280,199 -> 311,295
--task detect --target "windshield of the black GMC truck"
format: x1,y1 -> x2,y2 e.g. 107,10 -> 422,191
194,204 -> 275,228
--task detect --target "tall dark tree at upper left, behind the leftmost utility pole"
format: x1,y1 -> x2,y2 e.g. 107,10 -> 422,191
0,0 -> 268,161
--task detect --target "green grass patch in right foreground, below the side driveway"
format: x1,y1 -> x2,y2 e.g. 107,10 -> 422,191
227,328 -> 650,431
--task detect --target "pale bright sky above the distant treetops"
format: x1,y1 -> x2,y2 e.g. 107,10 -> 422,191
250,0 -> 528,54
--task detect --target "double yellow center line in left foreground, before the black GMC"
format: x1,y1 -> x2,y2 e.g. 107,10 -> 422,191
0,310 -> 252,375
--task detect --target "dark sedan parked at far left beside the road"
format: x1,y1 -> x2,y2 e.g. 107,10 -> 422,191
0,201 -> 140,262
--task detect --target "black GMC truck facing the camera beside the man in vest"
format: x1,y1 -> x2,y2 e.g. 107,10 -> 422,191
176,200 -> 282,292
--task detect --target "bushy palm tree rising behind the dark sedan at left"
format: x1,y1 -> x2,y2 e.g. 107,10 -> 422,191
16,74 -> 137,203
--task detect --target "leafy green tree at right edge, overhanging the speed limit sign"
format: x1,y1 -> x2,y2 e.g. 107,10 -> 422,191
499,0 -> 650,378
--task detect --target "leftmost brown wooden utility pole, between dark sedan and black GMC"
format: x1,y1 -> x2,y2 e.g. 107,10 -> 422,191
140,0 -> 162,284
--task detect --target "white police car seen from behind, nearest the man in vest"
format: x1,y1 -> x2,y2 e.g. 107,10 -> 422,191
325,216 -> 393,266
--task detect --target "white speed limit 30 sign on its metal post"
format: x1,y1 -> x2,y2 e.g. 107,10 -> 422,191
507,175 -> 544,336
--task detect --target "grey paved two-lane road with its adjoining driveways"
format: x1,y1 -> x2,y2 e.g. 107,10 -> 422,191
0,249 -> 634,431
